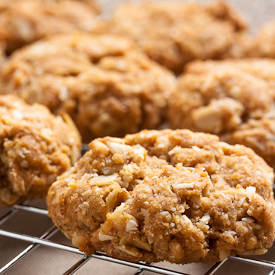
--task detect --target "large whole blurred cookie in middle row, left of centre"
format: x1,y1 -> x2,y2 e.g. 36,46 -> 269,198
0,34 -> 176,142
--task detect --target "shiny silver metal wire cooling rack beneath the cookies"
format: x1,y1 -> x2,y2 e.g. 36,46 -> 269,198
0,144 -> 275,275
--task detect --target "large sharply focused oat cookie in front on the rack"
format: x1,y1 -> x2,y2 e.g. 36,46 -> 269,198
47,130 -> 275,263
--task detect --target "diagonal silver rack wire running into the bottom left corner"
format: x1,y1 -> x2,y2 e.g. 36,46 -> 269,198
0,226 -> 58,274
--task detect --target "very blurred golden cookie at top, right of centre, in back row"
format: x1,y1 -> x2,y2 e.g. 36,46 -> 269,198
111,1 -> 248,73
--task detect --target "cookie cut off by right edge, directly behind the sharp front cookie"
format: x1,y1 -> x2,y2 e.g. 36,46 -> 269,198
168,59 -> 275,168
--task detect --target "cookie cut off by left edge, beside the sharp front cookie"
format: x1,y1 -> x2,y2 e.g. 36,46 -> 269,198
0,95 -> 81,205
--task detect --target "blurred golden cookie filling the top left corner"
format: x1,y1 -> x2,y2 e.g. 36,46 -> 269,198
0,0 -> 103,54
